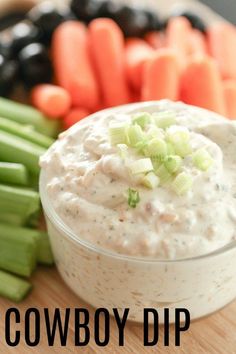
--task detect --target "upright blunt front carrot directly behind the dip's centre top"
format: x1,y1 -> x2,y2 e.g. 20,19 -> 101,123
141,48 -> 180,101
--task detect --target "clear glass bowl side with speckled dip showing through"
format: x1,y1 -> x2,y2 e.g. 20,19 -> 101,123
40,102 -> 236,323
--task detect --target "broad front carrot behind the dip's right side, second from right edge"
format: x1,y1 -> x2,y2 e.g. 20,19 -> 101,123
181,56 -> 225,115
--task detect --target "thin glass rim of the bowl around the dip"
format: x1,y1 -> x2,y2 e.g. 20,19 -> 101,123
39,100 -> 236,264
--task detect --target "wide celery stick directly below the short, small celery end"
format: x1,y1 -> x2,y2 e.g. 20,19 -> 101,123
0,184 -> 40,222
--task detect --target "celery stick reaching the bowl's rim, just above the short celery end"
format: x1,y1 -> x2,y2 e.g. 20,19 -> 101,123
0,130 -> 46,174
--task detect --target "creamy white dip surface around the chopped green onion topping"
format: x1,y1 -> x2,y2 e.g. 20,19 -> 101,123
41,101 -> 236,259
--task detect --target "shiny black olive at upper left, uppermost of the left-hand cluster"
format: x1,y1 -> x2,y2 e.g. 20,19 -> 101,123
9,22 -> 40,58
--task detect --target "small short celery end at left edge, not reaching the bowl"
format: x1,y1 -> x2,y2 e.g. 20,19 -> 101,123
0,162 -> 28,186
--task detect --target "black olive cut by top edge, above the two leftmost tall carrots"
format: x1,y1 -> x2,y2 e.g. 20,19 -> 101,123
70,0 -> 105,22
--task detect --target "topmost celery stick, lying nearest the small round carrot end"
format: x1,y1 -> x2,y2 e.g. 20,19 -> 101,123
0,97 -> 59,136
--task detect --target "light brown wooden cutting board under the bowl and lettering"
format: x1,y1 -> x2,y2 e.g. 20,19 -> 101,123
0,268 -> 236,354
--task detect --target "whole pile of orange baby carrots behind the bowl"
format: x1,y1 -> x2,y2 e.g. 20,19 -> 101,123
32,17 -> 236,129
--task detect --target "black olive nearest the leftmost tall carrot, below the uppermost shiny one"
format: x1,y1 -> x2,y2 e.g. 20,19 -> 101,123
19,43 -> 52,88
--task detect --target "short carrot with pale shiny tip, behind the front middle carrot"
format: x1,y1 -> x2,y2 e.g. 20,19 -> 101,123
125,38 -> 154,91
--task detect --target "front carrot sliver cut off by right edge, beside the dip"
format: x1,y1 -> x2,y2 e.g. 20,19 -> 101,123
223,80 -> 236,119
